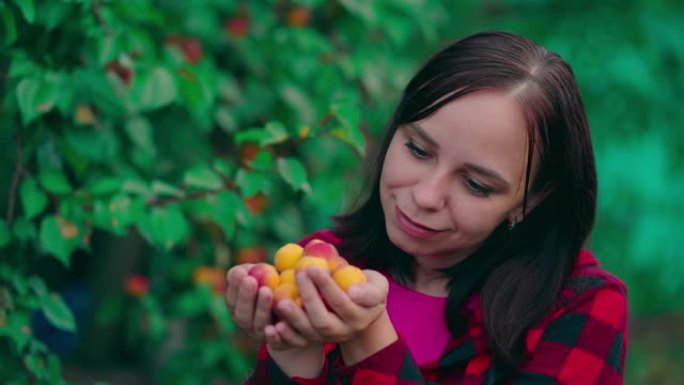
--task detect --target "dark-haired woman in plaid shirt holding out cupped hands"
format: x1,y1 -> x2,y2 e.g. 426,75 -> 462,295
226,32 -> 627,384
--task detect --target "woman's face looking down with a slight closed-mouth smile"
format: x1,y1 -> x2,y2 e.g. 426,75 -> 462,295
380,91 -> 536,269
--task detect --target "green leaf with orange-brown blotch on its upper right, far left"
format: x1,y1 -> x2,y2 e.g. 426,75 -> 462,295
40,215 -> 80,267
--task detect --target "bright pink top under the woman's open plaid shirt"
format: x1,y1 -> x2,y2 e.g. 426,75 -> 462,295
387,277 -> 451,365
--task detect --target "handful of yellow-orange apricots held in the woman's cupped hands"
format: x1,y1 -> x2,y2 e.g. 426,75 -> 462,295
248,239 -> 366,306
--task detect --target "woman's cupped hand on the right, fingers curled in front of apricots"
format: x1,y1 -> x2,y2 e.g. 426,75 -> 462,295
269,267 -> 389,342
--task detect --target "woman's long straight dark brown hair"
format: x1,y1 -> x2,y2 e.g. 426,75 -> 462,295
333,32 -> 596,367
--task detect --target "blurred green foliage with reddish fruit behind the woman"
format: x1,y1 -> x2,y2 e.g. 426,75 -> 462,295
0,0 -> 684,385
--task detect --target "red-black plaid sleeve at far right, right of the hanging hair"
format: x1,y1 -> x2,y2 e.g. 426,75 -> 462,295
512,284 -> 627,385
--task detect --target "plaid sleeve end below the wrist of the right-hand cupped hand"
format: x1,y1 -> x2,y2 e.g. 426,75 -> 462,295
330,338 -> 428,385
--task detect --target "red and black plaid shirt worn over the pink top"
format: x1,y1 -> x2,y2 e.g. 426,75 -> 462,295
246,231 -> 627,385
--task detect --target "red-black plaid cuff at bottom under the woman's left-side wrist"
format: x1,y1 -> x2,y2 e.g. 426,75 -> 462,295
244,344 -> 328,385
